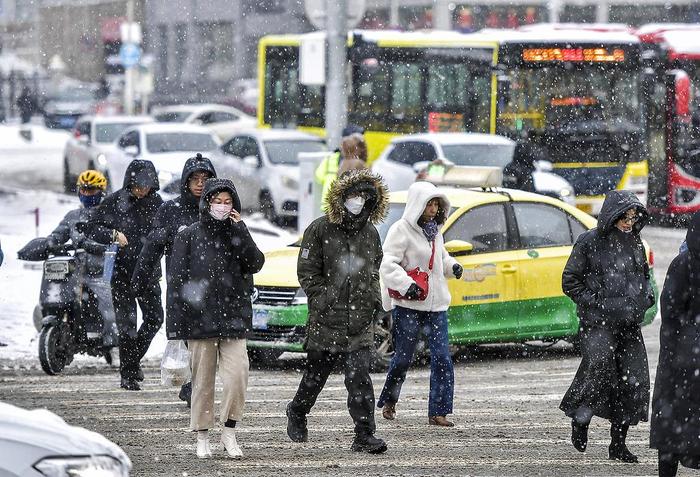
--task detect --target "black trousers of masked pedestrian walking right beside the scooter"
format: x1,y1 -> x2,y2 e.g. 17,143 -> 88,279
112,277 -> 163,379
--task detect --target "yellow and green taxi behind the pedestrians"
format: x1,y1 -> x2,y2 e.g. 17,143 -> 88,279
248,180 -> 658,368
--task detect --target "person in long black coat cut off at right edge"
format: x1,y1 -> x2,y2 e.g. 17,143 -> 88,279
650,213 -> 700,477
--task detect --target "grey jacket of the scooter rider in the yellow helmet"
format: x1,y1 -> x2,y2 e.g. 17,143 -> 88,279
46,207 -> 110,276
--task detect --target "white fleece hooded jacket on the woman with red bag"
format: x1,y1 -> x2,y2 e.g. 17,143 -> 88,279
379,182 -> 457,311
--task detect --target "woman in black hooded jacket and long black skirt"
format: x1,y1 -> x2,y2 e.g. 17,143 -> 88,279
559,190 -> 655,462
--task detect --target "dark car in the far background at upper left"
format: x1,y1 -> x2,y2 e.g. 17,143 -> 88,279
43,85 -> 97,129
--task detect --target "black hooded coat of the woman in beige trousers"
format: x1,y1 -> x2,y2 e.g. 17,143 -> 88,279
166,179 -> 265,339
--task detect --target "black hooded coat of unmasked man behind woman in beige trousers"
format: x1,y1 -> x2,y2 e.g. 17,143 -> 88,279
131,154 -> 216,295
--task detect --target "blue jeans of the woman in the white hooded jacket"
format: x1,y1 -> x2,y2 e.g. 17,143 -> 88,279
377,306 -> 454,416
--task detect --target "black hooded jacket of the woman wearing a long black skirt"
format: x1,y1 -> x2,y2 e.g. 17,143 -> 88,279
562,190 -> 654,326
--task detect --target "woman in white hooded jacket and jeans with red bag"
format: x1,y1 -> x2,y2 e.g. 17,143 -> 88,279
377,182 -> 463,427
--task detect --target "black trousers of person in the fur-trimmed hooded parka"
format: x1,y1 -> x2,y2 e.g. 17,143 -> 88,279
291,348 -> 376,435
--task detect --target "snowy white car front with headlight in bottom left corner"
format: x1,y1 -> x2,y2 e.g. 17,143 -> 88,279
0,402 -> 131,477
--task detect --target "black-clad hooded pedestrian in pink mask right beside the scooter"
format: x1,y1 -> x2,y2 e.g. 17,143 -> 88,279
91,159 -> 163,391
